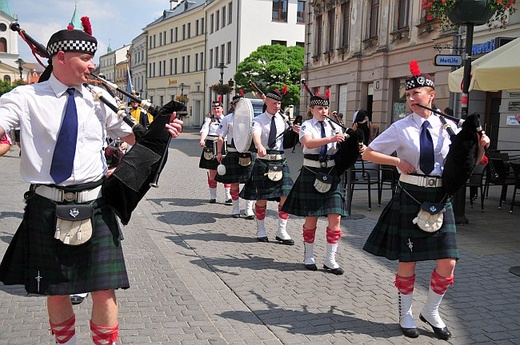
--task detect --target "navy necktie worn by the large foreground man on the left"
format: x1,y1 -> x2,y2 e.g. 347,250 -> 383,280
50,88 -> 78,184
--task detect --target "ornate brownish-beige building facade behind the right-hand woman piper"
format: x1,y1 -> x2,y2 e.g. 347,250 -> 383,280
301,0 -> 520,148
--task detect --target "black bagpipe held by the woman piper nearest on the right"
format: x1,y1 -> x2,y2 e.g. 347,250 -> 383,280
417,104 -> 498,195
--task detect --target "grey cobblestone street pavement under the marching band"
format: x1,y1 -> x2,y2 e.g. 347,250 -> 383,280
0,130 -> 520,345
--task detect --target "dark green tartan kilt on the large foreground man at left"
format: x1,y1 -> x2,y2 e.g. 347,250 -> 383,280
0,195 -> 130,295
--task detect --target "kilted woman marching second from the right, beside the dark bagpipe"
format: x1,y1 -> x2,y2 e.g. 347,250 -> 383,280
282,90 -> 358,275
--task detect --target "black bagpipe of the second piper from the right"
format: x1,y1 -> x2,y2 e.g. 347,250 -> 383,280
301,79 -> 363,175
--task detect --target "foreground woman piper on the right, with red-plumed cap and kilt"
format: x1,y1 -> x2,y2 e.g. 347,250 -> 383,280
363,61 -> 489,340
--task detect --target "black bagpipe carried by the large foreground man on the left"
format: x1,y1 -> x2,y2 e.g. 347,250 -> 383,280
10,22 -> 186,225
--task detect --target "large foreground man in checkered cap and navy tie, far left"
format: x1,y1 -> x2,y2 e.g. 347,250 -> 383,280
0,21 -> 182,344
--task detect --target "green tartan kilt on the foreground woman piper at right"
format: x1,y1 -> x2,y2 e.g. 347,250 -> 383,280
363,182 -> 459,262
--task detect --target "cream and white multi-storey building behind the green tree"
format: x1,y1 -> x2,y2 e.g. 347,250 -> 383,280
131,0 -> 306,126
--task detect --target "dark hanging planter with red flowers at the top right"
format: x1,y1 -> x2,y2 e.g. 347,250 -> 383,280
422,0 -> 516,28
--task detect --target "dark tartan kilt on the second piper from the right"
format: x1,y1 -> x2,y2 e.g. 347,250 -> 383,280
282,166 -> 348,217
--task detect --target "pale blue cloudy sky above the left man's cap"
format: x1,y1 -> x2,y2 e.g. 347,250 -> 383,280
9,0 -> 170,63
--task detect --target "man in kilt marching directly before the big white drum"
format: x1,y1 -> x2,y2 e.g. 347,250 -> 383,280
240,89 -> 299,245
